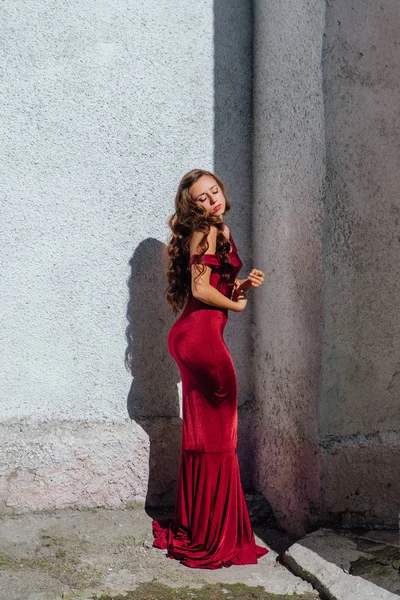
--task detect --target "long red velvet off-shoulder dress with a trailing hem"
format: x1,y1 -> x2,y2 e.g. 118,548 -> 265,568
152,229 -> 268,569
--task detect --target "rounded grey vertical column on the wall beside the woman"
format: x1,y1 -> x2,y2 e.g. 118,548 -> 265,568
253,0 -> 325,533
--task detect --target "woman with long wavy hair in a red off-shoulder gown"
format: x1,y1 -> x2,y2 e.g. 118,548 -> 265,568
152,169 -> 268,569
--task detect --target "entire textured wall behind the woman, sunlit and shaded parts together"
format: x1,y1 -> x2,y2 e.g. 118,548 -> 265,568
0,0 -> 400,533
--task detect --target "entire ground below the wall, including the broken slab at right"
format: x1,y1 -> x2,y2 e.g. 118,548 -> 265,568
0,505 -> 400,600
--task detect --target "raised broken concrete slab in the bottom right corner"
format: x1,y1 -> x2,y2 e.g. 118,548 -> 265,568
282,528 -> 400,600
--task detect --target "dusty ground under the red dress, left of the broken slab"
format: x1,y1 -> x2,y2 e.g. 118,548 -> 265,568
0,506 -> 320,600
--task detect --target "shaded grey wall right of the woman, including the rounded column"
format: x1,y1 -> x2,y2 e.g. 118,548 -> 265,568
253,0 -> 400,533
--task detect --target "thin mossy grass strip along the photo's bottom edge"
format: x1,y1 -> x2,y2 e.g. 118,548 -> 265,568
93,582 -> 318,600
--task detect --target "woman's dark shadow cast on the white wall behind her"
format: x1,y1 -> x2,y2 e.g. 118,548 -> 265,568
125,238 -> 182,508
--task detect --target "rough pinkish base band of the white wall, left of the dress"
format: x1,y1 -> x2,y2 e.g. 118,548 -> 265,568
0,417 -> 182,514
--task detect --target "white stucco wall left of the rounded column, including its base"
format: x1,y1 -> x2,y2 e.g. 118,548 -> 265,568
0,0 -> 251,512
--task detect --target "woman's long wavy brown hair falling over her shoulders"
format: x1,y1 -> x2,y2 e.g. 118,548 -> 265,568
165,169 -> 234,313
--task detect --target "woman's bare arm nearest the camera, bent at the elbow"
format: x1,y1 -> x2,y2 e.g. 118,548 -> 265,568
190,225 -> 247,312
